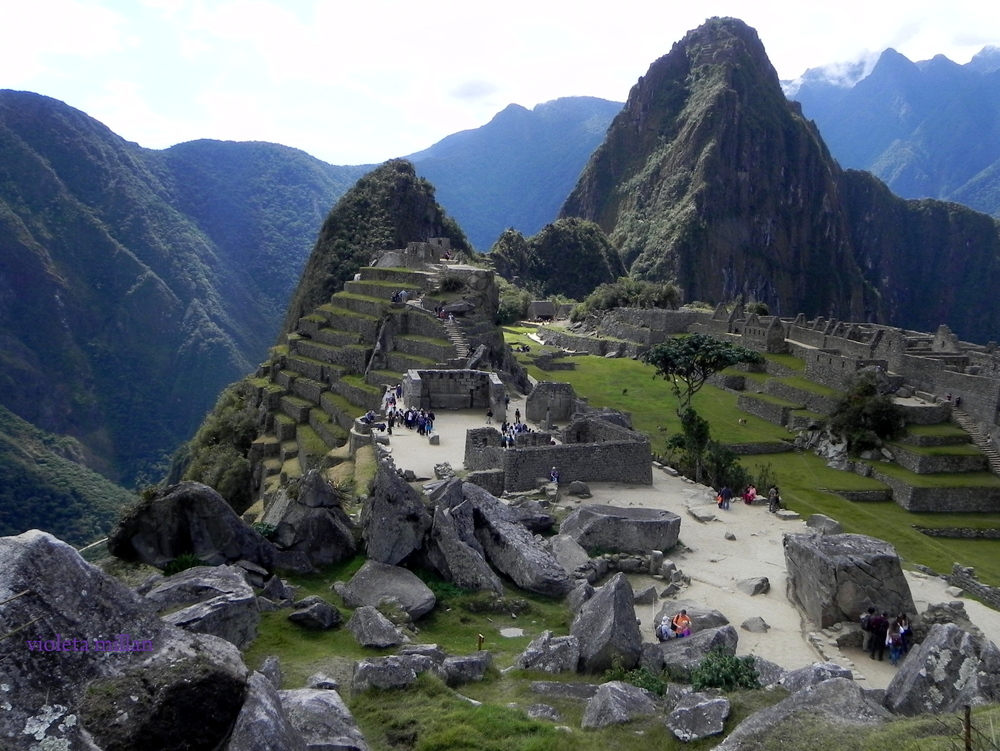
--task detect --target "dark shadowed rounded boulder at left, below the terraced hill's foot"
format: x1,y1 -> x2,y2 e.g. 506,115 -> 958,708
108,482 -> 275,570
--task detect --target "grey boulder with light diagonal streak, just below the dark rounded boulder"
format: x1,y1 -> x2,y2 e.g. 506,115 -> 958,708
146,566 -> 260,649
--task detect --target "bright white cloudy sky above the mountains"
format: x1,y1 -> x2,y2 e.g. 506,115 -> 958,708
0,0 -> 1000,164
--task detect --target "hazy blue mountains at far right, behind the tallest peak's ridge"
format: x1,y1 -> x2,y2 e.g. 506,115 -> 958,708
784,47 -> 1000,216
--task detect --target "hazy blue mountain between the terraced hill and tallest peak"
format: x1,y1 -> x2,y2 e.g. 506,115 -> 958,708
407,97 -> 622,250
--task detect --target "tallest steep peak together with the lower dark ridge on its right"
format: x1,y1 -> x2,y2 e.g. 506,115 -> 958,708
561,18 -> 1000,341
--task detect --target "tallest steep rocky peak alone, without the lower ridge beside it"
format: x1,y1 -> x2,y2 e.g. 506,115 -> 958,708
562,18 -> 880,320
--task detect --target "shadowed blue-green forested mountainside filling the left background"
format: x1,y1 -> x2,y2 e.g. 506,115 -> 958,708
0,91 -> 364,484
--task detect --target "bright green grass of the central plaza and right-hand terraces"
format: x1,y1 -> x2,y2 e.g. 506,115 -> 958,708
505,328 -> 1000,586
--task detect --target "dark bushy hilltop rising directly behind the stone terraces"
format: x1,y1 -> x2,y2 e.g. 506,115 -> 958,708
285,159 -> 472,333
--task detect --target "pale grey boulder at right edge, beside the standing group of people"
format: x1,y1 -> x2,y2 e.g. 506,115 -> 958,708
885,623 -> 1000,715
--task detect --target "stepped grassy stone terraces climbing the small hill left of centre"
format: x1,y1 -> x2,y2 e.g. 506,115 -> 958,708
250,267 -> 458,491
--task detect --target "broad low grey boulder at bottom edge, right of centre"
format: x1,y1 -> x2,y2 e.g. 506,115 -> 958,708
715,678 -> 891,751
